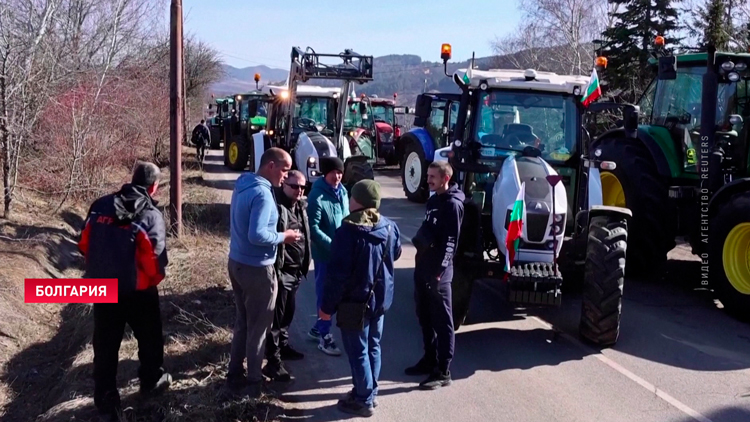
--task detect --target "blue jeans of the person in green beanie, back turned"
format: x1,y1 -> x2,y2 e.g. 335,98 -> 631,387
341,314 -> 385,407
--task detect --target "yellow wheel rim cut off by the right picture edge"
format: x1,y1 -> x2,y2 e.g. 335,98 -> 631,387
722,223 -> 750,295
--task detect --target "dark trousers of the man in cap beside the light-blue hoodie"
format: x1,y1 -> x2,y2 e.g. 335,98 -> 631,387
266,274 -> 300,364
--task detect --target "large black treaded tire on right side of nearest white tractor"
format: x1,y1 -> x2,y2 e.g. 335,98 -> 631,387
579,213 -> 628,347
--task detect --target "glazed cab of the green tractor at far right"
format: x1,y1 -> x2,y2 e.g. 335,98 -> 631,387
639,53 -> 750,186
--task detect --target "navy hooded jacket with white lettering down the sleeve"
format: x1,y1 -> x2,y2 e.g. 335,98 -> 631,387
412,183 -> 466,283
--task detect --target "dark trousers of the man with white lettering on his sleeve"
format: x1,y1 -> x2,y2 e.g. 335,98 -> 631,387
414,273 -> 455,372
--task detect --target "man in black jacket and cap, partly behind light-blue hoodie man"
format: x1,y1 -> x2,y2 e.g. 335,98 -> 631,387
263,170 -> 311,382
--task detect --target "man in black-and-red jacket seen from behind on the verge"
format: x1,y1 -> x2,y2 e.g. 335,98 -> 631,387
78,162 -> 172,420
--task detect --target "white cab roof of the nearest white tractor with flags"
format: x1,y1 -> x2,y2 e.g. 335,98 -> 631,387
453,69 -> 589,95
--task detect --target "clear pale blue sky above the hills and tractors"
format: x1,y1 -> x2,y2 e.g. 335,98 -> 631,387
179,0 -> 520,69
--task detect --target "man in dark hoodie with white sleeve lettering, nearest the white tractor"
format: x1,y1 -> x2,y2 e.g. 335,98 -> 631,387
406,161 -> 465,390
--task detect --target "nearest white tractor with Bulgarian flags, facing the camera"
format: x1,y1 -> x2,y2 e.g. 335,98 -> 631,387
432,44 -> 638,347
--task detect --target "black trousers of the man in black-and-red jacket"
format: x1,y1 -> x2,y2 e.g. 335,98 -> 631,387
93,287 -> 164,411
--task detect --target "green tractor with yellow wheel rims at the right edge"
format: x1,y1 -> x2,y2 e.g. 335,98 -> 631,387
592,37 -> 750,320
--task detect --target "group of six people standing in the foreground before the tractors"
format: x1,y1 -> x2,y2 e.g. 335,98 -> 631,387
79,148 -> 464,420
